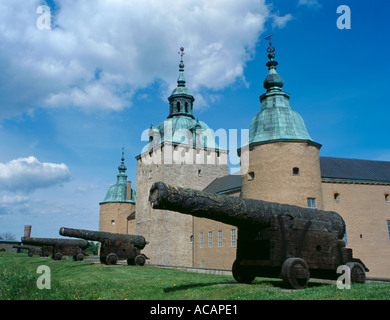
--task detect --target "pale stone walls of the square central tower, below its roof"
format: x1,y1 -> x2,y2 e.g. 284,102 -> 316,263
135,143 -> 228,267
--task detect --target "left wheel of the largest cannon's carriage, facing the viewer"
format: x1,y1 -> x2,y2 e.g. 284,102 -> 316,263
281,258 -> 310,289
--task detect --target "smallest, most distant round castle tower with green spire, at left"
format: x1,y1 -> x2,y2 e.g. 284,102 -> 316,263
99,150 -> 135,234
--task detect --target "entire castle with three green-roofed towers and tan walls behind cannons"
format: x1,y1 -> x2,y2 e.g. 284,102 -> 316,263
99,42 -> 390,277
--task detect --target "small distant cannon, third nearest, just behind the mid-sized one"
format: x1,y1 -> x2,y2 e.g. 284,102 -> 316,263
21,237 -> 89,261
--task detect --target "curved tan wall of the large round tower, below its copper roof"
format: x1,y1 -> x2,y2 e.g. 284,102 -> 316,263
241,140 -> 323,209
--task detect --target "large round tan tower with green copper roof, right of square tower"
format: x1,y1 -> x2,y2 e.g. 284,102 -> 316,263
241,37 -> 323,209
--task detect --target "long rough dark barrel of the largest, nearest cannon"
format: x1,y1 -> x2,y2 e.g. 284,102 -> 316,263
149,181 -> 345,239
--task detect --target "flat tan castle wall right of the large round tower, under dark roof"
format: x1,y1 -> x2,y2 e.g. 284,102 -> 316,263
322,180 -> 390,278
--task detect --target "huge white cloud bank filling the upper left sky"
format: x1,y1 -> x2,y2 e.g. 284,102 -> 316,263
0,0 -> 289,118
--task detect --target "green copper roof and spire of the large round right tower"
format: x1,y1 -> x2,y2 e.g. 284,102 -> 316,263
249,43 -> 312,143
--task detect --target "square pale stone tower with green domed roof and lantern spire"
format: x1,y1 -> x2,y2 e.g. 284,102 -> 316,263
136,48 -> 228,266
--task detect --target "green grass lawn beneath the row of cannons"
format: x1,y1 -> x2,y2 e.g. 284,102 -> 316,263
0,252 -> 390,300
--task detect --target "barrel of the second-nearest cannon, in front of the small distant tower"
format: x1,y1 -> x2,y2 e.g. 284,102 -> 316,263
59,227 -> 147,250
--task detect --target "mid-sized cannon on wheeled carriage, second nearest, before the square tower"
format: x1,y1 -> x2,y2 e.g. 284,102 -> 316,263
59,227 -> 149,266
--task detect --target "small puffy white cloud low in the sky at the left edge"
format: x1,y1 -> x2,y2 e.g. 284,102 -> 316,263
0,156 -> 70,192
